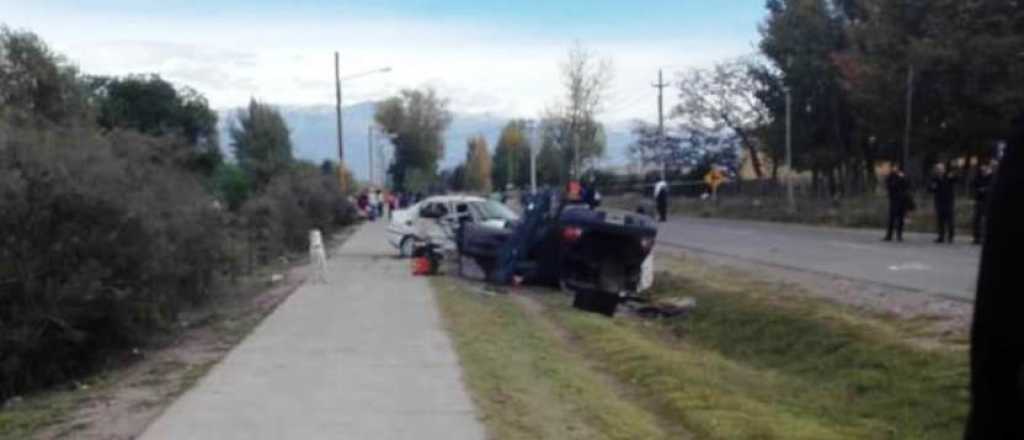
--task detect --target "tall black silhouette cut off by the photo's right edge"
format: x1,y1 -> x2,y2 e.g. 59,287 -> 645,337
964,116 -> 1024,440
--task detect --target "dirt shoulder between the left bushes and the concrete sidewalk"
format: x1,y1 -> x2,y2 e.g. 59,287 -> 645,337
0,231 -> 350,440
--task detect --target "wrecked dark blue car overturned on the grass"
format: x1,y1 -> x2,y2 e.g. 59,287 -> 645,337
457,193 -> 657,316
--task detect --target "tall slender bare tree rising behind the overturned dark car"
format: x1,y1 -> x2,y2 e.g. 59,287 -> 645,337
549,42 -> 612,178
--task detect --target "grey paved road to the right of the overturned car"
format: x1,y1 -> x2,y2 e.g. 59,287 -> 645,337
658,217 -> 980,300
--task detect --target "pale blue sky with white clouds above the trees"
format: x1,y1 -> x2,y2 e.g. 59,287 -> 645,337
0,0 -> 764,120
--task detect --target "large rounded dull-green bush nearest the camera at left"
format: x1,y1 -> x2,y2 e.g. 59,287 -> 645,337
0,122 -> 225,397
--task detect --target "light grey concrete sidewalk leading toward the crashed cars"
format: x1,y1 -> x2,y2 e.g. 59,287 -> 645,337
142,222 -> 484,440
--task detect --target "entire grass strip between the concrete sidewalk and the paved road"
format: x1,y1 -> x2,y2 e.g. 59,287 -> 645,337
435,252 -> 968,440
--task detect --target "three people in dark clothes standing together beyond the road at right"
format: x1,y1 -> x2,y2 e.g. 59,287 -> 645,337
885,160 -> 994,245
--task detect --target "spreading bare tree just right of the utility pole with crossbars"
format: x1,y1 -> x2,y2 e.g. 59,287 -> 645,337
672,56 -> 770,179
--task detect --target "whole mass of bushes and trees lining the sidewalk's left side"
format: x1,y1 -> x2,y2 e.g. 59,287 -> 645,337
0,27 -> 354,401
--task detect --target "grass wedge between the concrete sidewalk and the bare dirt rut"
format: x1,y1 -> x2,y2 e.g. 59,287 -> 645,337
433,278 -> 670,439
